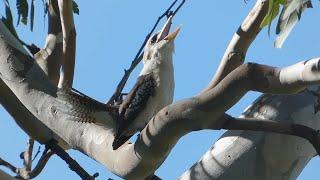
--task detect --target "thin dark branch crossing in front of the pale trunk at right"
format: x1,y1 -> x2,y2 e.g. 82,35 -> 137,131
222,115 -> 320,156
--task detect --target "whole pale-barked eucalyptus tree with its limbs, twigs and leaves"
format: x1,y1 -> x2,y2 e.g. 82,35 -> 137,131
0,0 -> 320,179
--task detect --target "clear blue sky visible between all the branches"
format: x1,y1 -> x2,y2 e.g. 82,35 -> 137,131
0,0 -> 320,180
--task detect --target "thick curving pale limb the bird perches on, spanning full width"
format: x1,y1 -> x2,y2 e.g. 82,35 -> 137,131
0,23 -> 320,179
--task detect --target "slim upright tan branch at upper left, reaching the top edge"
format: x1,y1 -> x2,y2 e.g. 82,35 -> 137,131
58,0 -> 76,87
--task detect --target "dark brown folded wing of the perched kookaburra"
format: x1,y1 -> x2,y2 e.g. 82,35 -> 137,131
113,74 -> 156,149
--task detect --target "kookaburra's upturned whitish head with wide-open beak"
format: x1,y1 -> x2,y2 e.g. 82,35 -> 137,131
143,16 -> 180,63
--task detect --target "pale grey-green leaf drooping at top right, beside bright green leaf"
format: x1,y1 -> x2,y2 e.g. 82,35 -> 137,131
274,0 -> 312,48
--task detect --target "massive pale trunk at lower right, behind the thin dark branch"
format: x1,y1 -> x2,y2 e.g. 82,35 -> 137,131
180,88 -> 320,180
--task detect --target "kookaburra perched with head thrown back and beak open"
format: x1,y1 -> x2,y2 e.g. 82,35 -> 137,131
112,16 -> 180,149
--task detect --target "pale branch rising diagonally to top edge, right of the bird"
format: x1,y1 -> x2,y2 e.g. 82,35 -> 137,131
204,0 -> 269,91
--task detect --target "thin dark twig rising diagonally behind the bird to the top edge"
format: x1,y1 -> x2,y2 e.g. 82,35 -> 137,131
107,0 -> 185,104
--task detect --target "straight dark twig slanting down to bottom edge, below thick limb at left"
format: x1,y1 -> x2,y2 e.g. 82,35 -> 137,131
46,140 -> 99,180
